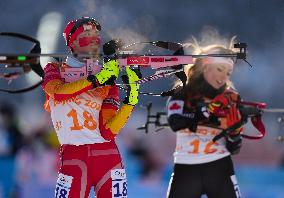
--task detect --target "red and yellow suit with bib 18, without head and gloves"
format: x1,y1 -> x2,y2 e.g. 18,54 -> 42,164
42,60 -> 134,198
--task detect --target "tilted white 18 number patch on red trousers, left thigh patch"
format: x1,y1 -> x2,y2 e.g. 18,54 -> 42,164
55,173 -> 73,198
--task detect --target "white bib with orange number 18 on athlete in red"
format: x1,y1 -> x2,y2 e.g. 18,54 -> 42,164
49,88 -> 106,145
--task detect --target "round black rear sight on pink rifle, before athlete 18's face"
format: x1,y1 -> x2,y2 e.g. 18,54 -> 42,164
103,39 -> 122,62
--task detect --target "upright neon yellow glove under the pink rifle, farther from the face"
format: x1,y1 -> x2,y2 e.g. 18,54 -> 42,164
121,67 -> 142,106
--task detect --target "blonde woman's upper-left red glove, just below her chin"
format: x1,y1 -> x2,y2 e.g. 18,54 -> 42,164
208,94 -> 229,117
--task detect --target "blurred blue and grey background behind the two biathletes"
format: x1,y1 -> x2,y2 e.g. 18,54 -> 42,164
0,0 -> 284,198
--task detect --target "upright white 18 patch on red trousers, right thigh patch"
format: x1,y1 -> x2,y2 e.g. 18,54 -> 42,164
111,169 -> 127,198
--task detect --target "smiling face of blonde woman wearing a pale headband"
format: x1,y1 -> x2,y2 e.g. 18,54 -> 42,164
203,63 -> 234,89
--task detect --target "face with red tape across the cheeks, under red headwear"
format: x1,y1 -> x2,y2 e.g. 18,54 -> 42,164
71,29 -> 101,56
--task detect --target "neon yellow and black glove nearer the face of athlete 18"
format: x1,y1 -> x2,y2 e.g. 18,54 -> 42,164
87,60 -> 119,88
